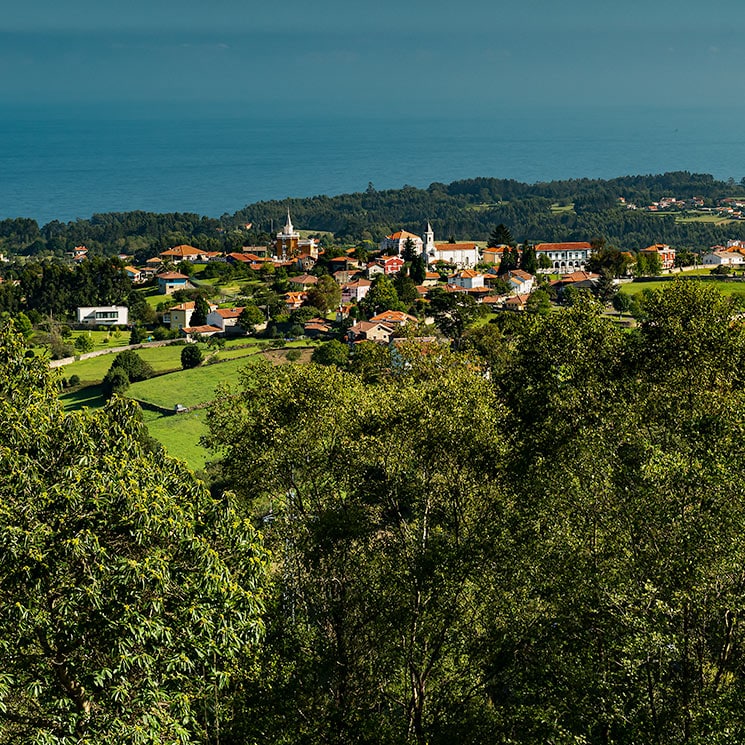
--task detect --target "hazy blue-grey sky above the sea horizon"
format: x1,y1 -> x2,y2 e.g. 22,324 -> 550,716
0,0 -> 745,116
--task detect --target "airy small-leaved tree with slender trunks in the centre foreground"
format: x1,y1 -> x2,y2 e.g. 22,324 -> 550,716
209,358 -> 511,744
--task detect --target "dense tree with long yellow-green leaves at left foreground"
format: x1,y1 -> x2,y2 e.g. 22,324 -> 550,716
0,328 -> 266,745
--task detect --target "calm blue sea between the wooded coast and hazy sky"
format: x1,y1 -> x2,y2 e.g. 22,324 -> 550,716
0,106 -> 745,224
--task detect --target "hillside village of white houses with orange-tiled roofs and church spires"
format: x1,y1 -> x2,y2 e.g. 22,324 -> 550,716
71,210 -> 745,352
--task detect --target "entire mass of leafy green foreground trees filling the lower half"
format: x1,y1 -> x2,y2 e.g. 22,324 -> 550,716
0,281 -> 745,745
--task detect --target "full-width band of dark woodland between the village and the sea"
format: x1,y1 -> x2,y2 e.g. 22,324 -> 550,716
0,171 -> 745,261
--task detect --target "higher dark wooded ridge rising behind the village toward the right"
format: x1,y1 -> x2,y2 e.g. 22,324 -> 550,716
230,171 -> 745,250
